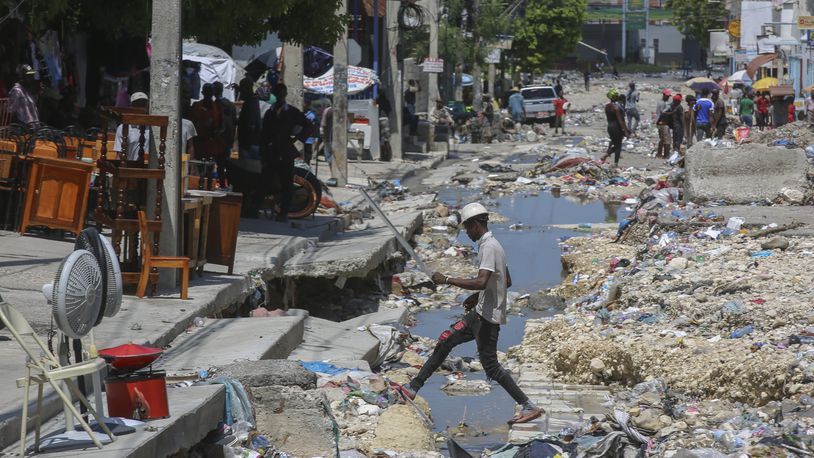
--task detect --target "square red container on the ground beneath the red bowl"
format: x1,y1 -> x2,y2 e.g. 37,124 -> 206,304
105,371 -> 170,421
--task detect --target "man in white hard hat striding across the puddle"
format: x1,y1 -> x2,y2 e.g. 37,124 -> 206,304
397,203 -> 543,424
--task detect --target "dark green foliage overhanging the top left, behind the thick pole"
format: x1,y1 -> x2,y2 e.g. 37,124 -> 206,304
0,0 -> 348,46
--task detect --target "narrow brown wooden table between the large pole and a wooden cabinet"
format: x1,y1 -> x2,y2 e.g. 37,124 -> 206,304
181,196 -> 212,278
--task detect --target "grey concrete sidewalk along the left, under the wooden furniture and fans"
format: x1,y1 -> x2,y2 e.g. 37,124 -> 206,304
0,155 -> 444,450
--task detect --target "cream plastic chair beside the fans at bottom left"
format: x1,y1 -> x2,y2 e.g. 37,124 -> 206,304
0,298 -> 116,456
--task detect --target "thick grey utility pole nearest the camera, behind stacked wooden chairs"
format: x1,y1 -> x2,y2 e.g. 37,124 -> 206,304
150,0 -> 182,288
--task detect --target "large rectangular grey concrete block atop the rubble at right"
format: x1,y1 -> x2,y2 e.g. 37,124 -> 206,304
684,142 -> 808,203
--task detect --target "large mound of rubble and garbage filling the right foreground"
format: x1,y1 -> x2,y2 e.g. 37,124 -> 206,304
509,151 -> 814,456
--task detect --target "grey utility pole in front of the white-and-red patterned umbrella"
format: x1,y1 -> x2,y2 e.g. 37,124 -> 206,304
331,0 -> 348,186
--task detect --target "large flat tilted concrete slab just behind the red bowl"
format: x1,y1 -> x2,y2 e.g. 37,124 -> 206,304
158,316 -> 305,375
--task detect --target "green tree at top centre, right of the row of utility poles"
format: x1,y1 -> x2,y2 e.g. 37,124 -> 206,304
511,0 -> 588,71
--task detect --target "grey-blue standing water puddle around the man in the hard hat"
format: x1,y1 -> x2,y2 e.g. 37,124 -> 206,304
412,188 -> 628,453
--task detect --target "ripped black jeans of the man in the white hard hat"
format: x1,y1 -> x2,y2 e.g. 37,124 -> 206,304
410,310 -> 529,405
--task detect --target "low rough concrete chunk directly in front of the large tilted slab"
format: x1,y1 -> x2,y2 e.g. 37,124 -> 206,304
218,359 -> 317,390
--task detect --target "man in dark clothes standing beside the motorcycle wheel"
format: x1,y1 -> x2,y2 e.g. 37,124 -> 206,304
262,83 -> 311,222
